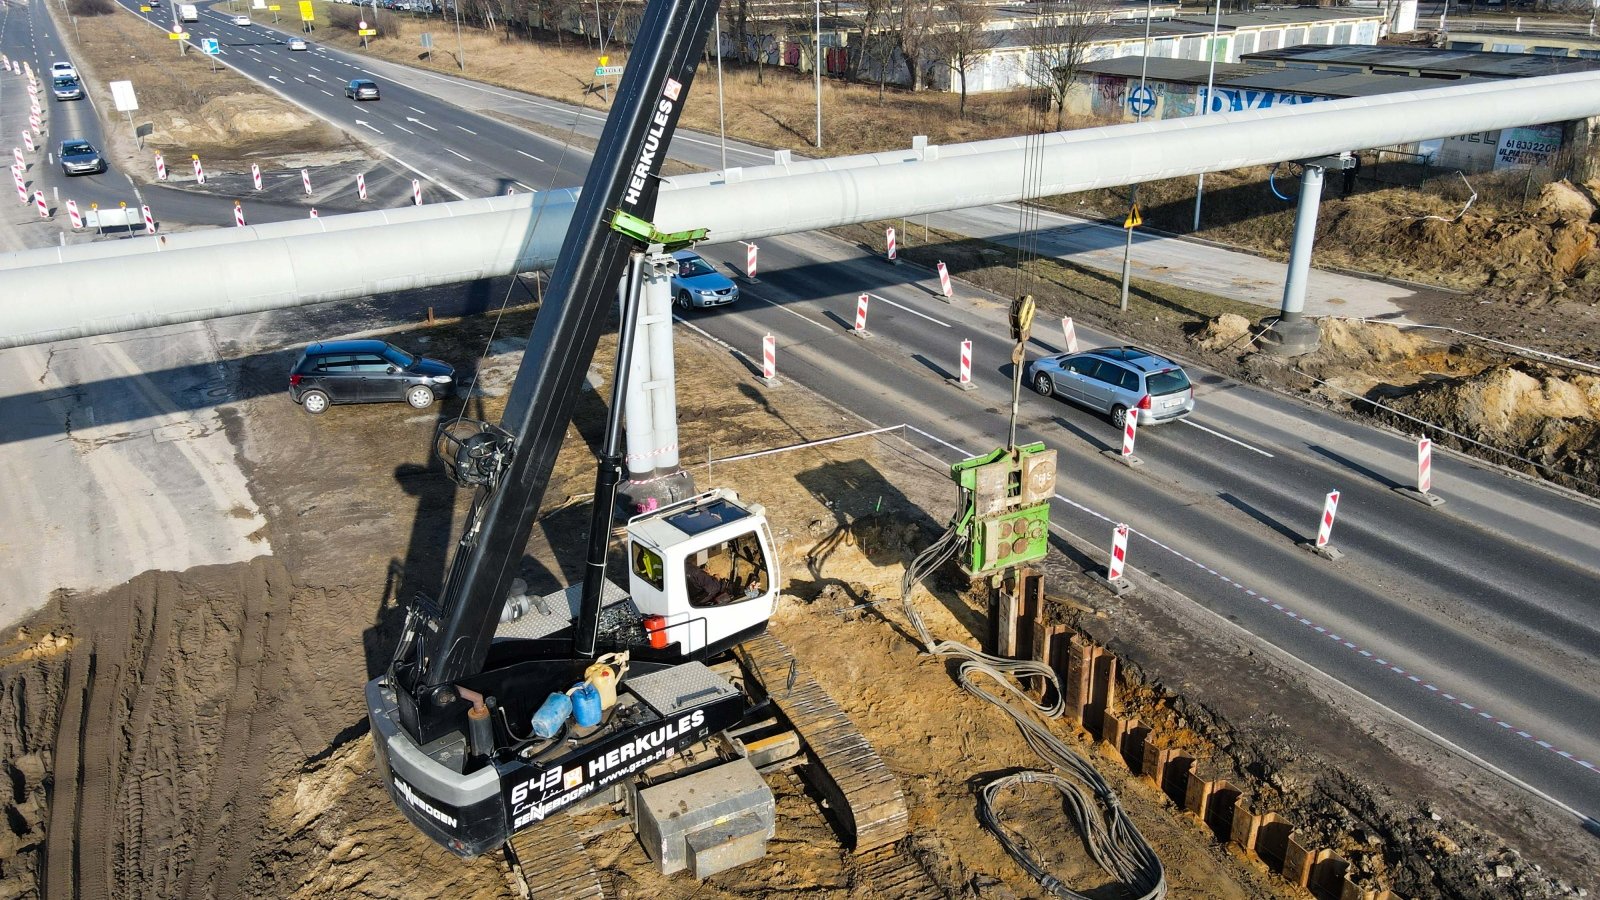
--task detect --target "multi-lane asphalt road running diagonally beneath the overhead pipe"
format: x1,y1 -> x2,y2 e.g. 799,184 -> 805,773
9,0 -> 1600,830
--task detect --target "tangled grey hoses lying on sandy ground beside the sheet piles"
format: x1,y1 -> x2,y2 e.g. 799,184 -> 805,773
901,525 -> 1166,900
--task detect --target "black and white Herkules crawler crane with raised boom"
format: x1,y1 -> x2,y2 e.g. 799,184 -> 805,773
366,0 -> 906,874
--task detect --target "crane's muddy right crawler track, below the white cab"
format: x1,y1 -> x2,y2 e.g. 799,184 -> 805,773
734,633 -> 907,854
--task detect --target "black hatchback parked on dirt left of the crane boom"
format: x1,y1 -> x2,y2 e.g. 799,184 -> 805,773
290,341 -> 456,415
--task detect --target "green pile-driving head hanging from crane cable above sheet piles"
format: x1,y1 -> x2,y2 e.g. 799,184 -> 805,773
950,442 -> 1056,575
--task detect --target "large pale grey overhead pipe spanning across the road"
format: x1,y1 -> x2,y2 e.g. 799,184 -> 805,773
0,72 -> 1600,348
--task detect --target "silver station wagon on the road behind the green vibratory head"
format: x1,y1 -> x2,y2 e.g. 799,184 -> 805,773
1024,348 -> 1195,428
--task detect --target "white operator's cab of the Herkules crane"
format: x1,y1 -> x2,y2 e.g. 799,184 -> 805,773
627,488 -> 781,657
